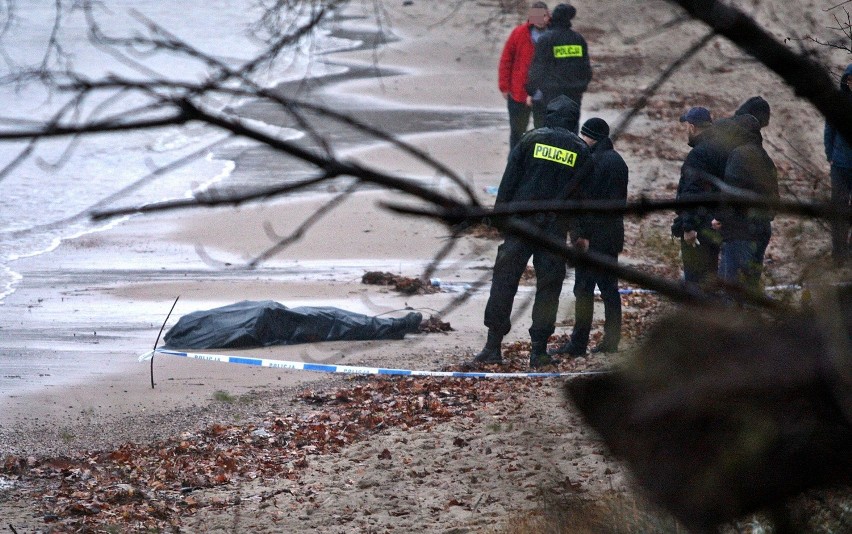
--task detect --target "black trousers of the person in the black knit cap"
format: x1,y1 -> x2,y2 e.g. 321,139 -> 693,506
571,252 -> 621,348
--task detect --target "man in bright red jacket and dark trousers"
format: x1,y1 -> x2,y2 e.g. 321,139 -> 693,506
498,2 -> 550,151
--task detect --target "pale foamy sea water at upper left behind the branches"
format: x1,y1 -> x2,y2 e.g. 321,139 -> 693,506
0,0 -> 357,305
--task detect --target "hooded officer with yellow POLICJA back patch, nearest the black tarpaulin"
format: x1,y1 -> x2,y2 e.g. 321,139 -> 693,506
472,96 -> 593,367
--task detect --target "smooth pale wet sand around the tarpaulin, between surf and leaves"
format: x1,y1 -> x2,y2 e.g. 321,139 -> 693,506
0,3 -> 540,453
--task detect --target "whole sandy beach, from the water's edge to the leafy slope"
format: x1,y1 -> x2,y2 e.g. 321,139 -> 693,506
0,1 -> 844,532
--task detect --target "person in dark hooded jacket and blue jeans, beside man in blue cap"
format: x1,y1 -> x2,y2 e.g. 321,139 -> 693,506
713,104 -> 779,292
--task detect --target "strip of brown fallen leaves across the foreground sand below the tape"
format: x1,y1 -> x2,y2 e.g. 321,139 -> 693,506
0,377 -> 514,531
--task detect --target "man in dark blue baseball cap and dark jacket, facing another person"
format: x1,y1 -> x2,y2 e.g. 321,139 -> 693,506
672,106 -> 727,284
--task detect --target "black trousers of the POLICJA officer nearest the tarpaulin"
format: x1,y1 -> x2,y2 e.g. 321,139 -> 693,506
485,232 -> 567,341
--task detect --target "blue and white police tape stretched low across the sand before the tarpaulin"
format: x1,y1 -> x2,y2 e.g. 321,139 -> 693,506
139,348 -> 605,378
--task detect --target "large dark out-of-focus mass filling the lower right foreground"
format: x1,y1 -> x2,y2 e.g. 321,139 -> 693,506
566,289 -> 852,532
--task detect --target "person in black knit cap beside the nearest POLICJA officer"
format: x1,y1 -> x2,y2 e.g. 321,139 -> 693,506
552,117 -> 629,356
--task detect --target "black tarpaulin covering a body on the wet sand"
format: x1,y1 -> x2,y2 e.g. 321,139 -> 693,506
163,300 -> 422,349
